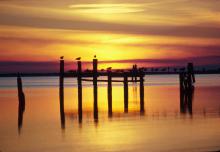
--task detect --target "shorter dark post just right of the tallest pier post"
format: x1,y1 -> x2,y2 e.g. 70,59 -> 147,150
107,69 -> 112,117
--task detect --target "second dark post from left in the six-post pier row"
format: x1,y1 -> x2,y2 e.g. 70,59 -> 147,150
77,60 -> 82,122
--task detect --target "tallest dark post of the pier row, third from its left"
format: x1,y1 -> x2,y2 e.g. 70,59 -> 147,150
93,58 -> 98,120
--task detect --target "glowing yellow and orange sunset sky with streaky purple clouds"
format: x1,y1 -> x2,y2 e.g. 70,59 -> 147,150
0,0 -> 220,72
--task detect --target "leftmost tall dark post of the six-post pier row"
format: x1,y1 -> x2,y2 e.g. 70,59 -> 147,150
59,57 -> 65,129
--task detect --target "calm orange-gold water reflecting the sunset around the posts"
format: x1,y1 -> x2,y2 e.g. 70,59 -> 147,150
0,75 -> 220,152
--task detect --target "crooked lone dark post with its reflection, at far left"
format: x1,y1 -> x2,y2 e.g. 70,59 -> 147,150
17,74 -> 25,132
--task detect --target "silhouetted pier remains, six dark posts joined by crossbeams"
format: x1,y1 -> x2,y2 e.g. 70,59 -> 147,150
59,57 -> 145,122
